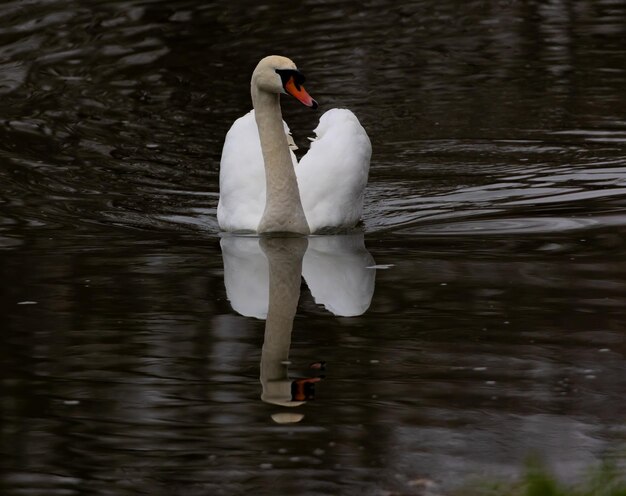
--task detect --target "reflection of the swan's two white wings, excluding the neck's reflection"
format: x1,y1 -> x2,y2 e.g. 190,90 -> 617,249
220,234 -> 376,319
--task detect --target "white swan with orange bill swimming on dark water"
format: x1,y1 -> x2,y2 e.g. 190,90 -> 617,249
217,55 -> 372,235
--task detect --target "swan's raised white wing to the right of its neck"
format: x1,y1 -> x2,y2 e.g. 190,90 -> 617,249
296,109 -> 372,232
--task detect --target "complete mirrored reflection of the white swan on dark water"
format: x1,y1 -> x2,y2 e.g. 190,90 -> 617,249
220,234 -> 376,422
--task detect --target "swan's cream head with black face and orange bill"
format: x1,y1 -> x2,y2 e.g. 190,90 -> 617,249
251,55 -> 317,109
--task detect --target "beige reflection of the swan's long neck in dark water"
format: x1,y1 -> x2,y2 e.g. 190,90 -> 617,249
260,238 -> 307,406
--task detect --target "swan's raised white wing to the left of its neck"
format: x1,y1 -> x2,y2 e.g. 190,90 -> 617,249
217,110 -> 296,231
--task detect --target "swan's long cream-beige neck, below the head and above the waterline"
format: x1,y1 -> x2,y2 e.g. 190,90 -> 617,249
252,84 -> 310,234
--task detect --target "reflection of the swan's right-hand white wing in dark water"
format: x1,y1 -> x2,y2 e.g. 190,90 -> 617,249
302,234 -> 376,317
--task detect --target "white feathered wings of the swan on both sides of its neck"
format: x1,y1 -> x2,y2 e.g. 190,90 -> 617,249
217,109 -> 372,232
